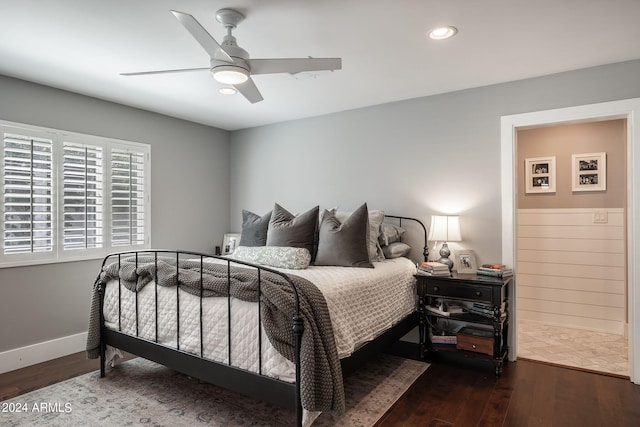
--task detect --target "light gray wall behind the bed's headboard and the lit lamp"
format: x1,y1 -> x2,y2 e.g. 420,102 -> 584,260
230,61 -> 640,263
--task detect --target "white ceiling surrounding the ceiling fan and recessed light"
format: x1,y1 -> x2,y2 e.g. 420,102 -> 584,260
0,0 -> 640,130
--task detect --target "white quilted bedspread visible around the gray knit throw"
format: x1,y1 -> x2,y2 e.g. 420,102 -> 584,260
104,258 -> 417,382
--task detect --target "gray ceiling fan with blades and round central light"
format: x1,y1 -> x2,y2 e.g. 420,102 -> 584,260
121,9 -> 342,104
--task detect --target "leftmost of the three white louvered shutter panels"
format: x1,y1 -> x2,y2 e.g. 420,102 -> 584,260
2,132 -> 54,255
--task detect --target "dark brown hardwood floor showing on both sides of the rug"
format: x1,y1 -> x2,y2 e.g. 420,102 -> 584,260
0,353 -> 640,427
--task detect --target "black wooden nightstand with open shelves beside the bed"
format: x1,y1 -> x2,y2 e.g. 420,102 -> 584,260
416,273 -> 512,376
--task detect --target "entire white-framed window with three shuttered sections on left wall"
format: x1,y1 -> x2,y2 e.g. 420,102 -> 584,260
0,122 -> 150,267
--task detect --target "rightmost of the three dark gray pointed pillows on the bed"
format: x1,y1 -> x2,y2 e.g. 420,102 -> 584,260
315,203 -> 373,268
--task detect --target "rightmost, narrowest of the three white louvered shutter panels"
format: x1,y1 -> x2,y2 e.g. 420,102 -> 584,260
111,149 -> 146,246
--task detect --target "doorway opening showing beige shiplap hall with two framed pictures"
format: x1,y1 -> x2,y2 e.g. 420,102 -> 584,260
515,119 -> 629,376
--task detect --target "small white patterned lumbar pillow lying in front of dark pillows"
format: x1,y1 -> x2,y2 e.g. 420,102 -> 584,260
232,246 -> 311,270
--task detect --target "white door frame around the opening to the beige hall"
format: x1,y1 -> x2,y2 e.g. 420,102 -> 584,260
500,98 -> 640,384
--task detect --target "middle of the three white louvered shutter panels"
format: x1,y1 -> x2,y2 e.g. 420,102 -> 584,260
63,142 -> 104,251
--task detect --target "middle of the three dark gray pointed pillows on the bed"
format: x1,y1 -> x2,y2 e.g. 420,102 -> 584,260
267,203 -> 320,259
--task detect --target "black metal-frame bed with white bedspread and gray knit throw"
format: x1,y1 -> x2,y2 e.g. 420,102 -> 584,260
87,205 -> 427,425
